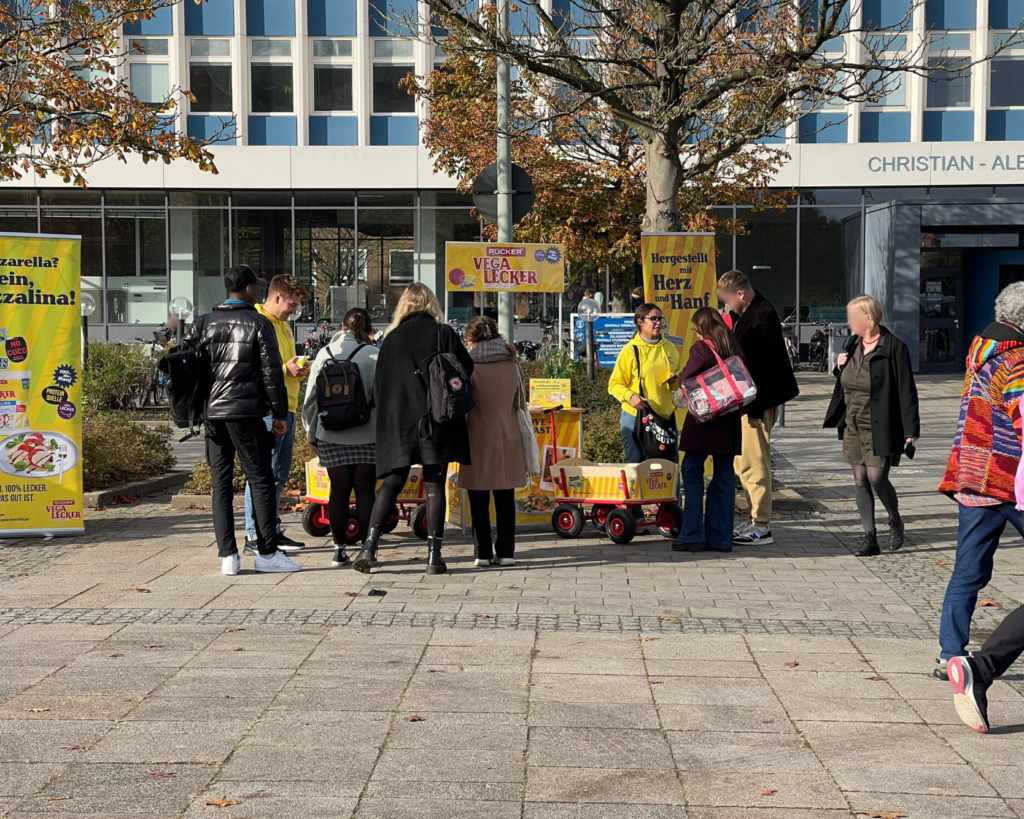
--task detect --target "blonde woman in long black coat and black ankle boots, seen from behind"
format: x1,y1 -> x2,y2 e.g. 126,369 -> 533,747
352,283 -> 473,574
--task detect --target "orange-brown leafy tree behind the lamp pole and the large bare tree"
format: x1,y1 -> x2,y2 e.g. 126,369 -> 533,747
407,39 -> 792,302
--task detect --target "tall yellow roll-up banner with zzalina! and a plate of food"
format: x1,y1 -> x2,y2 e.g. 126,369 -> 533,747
0,233 -> 83,535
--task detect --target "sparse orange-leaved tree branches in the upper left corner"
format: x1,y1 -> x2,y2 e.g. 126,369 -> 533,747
0,0 -> 233,185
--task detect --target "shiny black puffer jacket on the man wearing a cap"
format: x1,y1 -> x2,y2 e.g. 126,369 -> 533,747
186,303 -> 289,421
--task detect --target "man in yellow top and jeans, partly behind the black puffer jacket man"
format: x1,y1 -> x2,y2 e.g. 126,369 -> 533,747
243,274 -> 309,555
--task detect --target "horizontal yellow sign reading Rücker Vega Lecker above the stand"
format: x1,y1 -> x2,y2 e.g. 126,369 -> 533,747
444,242 -> 565,293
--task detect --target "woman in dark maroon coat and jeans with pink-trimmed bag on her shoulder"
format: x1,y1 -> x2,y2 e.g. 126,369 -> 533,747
672,307 -> 742,552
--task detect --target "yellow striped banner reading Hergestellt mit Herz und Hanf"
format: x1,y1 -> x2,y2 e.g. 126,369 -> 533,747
640,233 -> 718,348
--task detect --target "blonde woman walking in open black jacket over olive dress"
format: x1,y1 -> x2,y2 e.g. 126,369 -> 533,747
824,296 -> 921,557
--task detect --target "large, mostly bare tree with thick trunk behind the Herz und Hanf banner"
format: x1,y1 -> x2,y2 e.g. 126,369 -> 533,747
399,0 -> 1019,230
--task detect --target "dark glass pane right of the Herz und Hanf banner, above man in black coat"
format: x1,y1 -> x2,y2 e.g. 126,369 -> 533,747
736,208 -> 797,321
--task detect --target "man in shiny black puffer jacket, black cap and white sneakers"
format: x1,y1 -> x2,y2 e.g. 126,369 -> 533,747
186,264 -> 302,575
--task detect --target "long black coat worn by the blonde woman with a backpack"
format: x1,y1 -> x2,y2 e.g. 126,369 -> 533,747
374,313 -> 473,476
